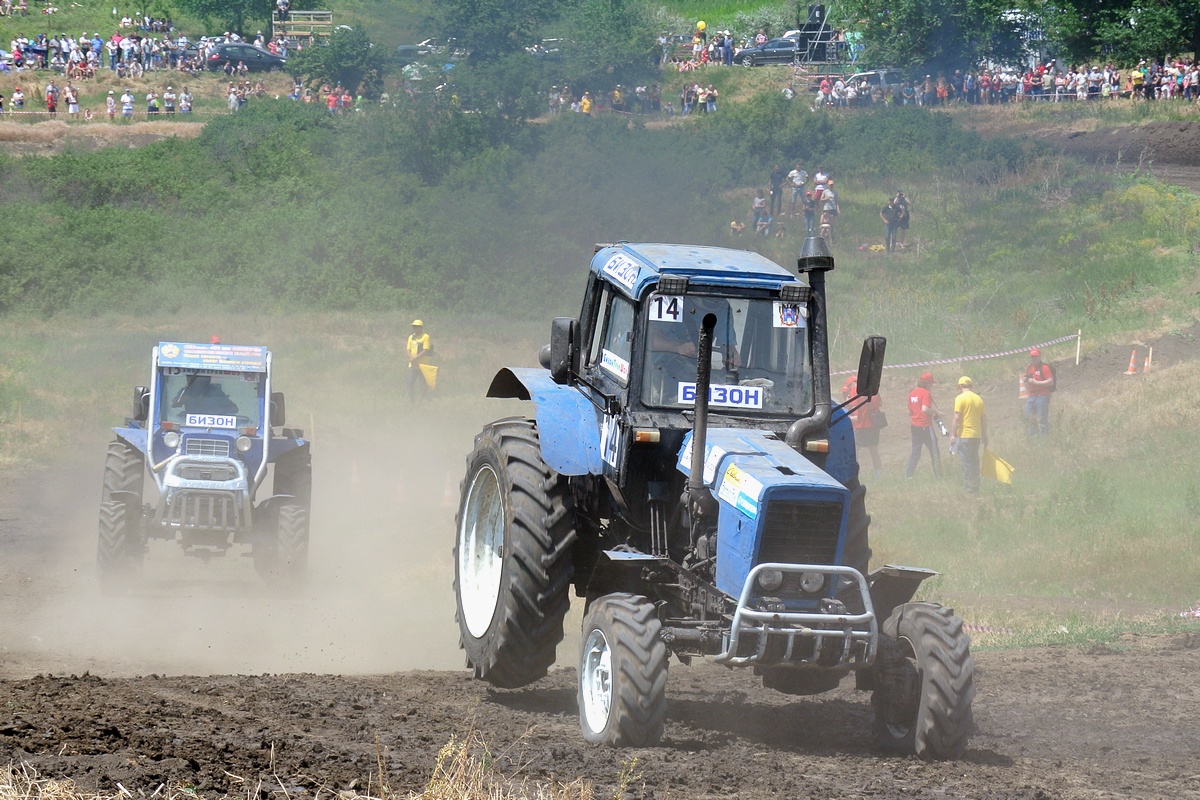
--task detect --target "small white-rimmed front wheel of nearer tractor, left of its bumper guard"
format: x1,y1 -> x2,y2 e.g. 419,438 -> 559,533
578,593 -> 668,747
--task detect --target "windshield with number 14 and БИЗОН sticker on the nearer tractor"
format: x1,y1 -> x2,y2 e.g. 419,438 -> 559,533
642,294 -> 812,416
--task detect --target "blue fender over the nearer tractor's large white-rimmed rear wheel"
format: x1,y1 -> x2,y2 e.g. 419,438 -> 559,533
487,367 -> 604,475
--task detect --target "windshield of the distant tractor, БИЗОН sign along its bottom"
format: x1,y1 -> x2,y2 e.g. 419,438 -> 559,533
158,367 -> 265,429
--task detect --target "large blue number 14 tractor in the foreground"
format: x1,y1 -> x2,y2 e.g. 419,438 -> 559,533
455,237 -> 974,758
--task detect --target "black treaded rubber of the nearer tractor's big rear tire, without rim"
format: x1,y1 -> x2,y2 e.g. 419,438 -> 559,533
455,419 -> 576,688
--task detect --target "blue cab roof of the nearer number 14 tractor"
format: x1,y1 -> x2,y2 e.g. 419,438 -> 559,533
592,242 -> 805,300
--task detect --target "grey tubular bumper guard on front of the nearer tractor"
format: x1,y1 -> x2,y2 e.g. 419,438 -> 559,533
714,564 -> 880,667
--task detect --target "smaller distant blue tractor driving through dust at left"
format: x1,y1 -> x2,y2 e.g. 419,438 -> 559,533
96,337 -> 312,591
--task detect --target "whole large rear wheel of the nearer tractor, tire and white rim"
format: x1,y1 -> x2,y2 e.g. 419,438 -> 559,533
454,419 -> 576,688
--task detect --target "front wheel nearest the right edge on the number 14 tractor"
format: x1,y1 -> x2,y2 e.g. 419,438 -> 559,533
871,603 -> 976,760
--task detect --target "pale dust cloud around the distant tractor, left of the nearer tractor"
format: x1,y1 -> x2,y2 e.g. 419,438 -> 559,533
0,393 -> 504,676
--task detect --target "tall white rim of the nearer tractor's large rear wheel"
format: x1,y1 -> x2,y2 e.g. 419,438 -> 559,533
458,464 -> 504,639
